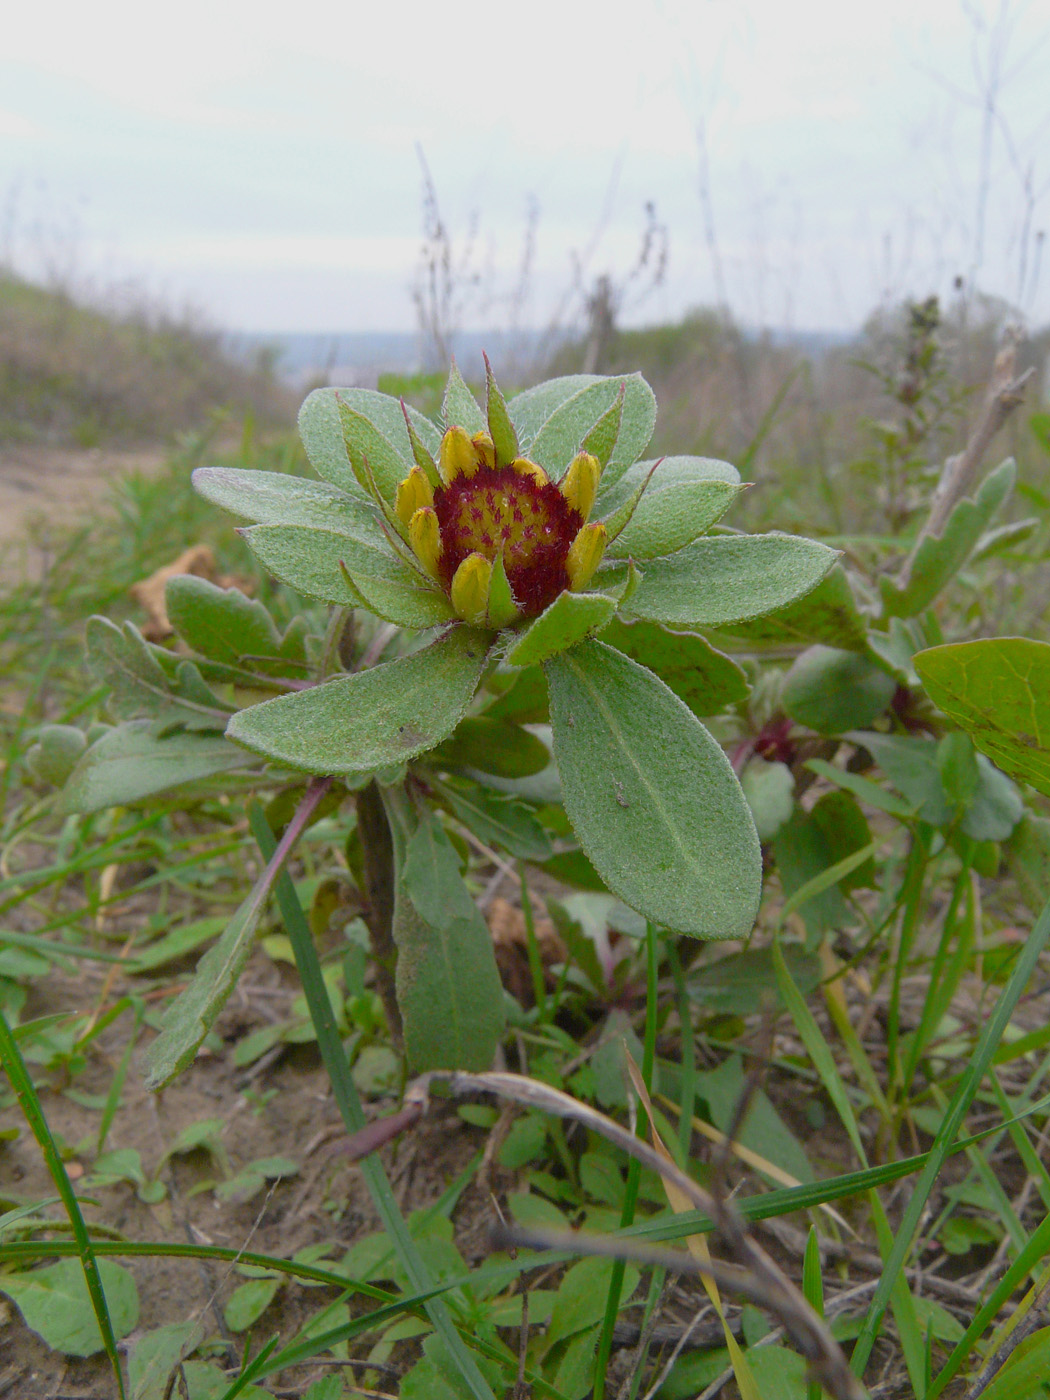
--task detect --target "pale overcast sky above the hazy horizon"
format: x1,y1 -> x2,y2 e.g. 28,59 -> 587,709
0,0 -> 1050,332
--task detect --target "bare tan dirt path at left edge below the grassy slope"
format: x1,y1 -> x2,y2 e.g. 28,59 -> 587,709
0,444 -> 167,580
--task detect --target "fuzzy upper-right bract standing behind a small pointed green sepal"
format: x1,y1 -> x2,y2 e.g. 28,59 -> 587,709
529,374 -> 657,486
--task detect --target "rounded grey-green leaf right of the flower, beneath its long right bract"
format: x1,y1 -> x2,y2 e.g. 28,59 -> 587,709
781,647 -> 896,734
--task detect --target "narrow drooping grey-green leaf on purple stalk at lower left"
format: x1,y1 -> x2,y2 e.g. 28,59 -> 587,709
146,851 -> 284,1080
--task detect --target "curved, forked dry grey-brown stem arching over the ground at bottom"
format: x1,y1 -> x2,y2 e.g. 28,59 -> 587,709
392,1070 -> 865,1400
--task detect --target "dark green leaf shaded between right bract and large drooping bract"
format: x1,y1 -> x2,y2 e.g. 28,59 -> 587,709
602,617 -> 748,718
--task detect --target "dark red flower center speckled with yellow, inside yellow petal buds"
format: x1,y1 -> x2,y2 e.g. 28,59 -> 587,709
434,466 -> 584,617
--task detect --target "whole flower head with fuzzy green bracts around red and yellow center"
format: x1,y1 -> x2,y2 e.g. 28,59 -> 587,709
195,368 -> 834,938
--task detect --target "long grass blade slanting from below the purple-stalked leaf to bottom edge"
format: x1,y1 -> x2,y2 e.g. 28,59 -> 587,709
248,802 -> 494,1400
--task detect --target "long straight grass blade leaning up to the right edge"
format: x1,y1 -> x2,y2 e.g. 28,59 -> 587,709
850,884 -> 1050,1376
